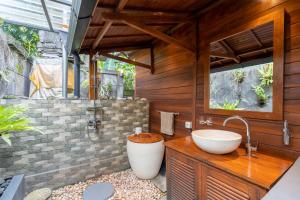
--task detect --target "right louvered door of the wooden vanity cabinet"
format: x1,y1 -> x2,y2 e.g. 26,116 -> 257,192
201,166 -> 265,200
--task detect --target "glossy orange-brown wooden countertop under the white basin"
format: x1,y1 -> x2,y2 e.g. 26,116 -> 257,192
165,136 -> 293,190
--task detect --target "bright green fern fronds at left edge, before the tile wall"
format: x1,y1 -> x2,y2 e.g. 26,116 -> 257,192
0,105 -> 42,145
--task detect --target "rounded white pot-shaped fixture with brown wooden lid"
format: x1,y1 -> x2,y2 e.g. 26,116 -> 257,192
127,133 -> 165,179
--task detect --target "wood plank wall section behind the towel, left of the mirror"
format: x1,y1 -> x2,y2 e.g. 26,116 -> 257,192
134,24 -> 196,138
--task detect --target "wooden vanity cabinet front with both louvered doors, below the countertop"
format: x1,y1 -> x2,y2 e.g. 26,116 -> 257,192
167,148 -> 266,200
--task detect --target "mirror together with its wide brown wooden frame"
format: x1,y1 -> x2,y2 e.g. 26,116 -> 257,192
200,12 -> 284,120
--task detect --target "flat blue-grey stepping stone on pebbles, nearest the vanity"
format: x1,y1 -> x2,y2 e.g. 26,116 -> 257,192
83,183 -> 114,200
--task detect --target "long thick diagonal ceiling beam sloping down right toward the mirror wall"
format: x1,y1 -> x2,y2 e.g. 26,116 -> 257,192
102,13 -> 195,53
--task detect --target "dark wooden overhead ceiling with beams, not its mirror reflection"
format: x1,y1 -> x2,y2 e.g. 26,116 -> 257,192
81,0 -> 221,52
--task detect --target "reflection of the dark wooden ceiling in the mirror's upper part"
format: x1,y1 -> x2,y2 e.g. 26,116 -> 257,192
210,22 -> 274,68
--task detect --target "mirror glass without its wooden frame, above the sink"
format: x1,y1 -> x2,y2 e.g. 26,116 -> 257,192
209,22 -> 274,112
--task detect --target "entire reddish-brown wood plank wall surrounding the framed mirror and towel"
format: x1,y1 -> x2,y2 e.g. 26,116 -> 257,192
136,0 -> 300,158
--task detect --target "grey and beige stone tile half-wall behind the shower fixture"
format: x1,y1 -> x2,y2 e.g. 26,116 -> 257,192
0,99 -> 149,192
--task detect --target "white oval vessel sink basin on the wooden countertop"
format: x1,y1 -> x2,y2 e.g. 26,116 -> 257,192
192,129 -> 242,154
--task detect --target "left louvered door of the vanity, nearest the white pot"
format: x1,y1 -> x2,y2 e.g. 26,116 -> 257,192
166,149 -> 198,200
